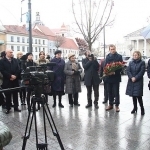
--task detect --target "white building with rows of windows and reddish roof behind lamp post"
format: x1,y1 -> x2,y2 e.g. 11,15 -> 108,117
0,25 -> 48,60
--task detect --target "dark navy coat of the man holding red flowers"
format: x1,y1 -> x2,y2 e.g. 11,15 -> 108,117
104,53 -> 123,83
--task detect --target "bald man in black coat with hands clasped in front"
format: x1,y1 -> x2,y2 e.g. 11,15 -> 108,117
0,49 -> 21,114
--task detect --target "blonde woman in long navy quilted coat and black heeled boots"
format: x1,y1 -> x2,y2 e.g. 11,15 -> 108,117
126,51 -> 145,115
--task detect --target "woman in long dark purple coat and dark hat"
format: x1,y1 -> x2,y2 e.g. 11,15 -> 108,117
50,50 -> 65,108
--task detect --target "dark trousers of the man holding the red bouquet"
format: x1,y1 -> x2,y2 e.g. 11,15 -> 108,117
107,82 -> 120,106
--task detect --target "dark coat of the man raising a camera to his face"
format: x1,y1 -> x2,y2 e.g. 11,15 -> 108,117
82,58 -> 100,86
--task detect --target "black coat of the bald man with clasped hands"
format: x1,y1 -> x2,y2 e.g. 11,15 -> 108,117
0,58 -> 20,88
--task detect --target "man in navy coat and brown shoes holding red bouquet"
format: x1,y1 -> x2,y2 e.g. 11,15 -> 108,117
105,44 -> 123,112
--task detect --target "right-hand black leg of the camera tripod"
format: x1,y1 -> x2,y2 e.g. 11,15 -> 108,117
44,104 -> 65,150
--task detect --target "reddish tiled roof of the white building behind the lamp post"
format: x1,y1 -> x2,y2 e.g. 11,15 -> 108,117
3,25 -> 47,38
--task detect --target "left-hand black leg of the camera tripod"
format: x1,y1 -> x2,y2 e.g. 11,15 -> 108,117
22,96 -> 33,150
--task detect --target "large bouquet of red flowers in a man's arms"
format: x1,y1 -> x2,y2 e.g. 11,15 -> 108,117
102,62 -> 125,78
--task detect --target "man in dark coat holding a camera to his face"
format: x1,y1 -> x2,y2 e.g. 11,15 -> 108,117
82,51 -> 100,109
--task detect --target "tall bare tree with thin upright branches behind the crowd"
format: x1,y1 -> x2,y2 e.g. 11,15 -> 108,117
72,0 -> 114,50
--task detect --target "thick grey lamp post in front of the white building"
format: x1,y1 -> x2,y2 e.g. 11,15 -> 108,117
21,0 -> 32,53
